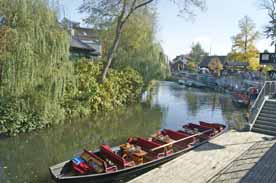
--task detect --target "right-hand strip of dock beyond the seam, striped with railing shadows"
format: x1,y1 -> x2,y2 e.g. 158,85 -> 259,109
209,140 -> 276,183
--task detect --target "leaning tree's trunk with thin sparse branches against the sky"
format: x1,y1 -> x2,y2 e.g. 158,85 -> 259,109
80,0 -> 205,82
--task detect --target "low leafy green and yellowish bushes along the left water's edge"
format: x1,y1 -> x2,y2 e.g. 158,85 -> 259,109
0,59 -> 144,135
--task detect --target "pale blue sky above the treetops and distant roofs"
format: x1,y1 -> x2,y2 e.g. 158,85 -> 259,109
61,0 -> 273,59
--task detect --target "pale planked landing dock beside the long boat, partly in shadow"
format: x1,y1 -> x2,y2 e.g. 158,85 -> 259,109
130,131 -> 276,183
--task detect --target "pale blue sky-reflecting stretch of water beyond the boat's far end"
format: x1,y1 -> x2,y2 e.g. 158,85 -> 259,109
152,82 -> 247,129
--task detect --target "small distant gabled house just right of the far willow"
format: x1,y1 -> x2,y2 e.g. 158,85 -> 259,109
170,55 -> 190,72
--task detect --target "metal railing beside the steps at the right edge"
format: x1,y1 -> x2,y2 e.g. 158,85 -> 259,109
249,81 -> 276,130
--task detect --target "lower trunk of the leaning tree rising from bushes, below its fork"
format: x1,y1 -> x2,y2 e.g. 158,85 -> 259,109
101,23 -> 123,83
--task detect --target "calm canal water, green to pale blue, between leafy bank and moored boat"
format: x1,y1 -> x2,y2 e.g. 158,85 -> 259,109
0,82 -> 246,183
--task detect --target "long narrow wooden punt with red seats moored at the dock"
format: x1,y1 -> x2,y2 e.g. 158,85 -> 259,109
49,122 -> 226,183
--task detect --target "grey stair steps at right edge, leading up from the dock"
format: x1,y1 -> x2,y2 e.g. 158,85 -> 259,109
252,101 -> 276,136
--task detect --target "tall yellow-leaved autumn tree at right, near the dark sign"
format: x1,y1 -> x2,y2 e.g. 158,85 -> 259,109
229,16 -> 259,70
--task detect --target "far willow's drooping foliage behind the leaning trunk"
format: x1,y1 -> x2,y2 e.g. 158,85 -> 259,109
101,8 -> 169,83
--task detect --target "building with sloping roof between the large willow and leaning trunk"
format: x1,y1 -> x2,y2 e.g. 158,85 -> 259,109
62,18 -> 102,59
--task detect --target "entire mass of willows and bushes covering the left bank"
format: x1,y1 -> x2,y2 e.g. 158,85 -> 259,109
0,0 -> 169,135
